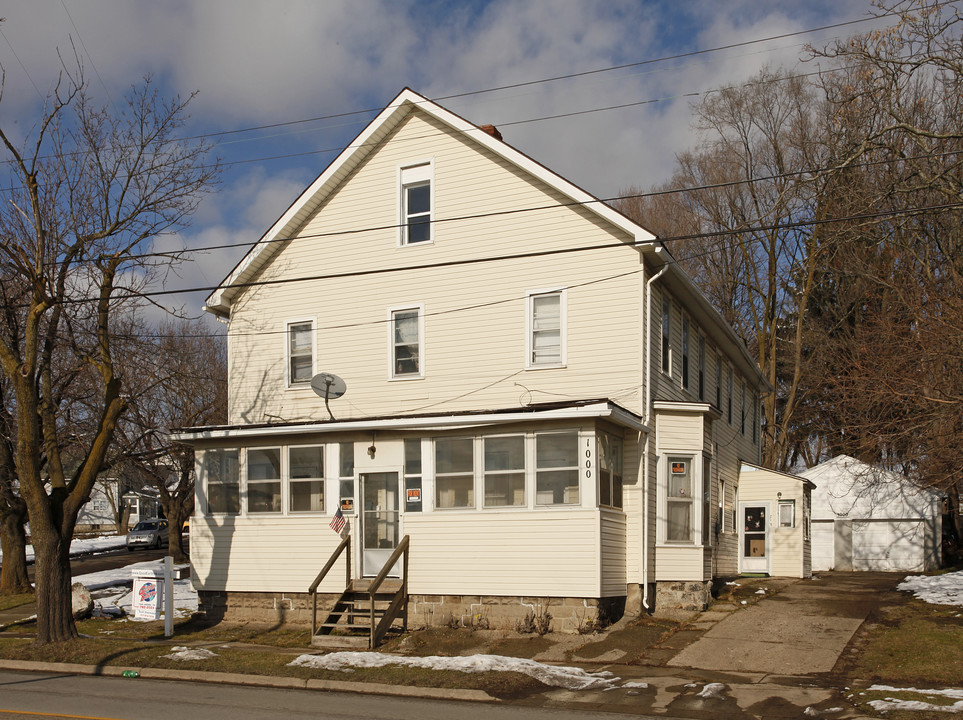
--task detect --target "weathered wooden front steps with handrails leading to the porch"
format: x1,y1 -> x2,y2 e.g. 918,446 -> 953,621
308,535 -> 408,648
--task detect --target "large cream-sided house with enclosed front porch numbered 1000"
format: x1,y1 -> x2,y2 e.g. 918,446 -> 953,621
175,90 -> 767,628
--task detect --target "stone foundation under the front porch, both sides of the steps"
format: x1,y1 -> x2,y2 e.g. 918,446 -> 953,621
198,590 -> 625,633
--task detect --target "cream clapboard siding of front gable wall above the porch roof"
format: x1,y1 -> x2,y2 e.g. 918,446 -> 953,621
230,111 -> 643,423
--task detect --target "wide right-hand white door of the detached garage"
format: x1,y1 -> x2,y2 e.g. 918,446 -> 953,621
852,520 -> 925,572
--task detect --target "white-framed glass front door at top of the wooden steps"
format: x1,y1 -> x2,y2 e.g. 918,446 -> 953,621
359,472 -> 401,577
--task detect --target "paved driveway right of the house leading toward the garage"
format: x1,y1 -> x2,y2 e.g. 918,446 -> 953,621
667,573 -> 906,675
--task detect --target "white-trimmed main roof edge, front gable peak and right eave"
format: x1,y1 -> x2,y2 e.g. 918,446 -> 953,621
204,88 -> 771,390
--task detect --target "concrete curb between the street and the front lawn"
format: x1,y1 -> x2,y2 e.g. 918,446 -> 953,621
0,660 -> 498,702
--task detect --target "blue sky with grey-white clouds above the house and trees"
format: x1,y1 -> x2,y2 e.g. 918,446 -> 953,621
0,0 -> 880,320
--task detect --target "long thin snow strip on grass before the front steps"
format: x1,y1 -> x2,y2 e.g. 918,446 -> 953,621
290,652 -> 648,690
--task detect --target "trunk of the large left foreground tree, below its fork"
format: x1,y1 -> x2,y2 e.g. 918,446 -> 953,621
33,535 -> 78,645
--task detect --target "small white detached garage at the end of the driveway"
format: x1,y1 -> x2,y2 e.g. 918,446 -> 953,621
800,455 -> 942,572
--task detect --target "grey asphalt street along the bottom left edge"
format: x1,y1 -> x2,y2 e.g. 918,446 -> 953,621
0,671 -> 648,720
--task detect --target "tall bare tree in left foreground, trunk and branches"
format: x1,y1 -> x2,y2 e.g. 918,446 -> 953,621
0,64 -> 217,644
